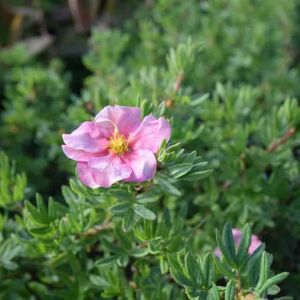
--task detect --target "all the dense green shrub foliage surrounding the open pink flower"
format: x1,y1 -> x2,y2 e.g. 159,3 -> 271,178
0,0 -> 300,300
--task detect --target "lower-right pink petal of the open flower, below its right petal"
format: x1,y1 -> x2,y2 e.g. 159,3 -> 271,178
122,150 -> 156,182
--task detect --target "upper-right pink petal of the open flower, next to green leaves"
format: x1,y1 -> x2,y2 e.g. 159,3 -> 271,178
129,115 -> 171,153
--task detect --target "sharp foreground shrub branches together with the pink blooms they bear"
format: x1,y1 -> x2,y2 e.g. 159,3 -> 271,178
0,103 -> 289,300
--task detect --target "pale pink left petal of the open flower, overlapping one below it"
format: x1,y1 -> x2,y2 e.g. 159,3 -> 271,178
63,122 -> 108,153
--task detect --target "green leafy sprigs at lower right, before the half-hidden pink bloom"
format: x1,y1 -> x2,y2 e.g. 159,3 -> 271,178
170,223 -> 288,300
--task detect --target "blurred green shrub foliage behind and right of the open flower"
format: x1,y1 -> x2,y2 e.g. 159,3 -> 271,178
75,0 -> 300,297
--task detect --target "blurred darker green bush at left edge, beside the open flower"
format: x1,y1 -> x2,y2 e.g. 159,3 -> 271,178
0,52 -> 71,194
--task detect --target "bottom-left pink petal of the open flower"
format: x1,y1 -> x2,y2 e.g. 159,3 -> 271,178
88,155 -> 132,187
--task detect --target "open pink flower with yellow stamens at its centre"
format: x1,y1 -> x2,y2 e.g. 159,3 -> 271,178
62,105 -> 171,188
